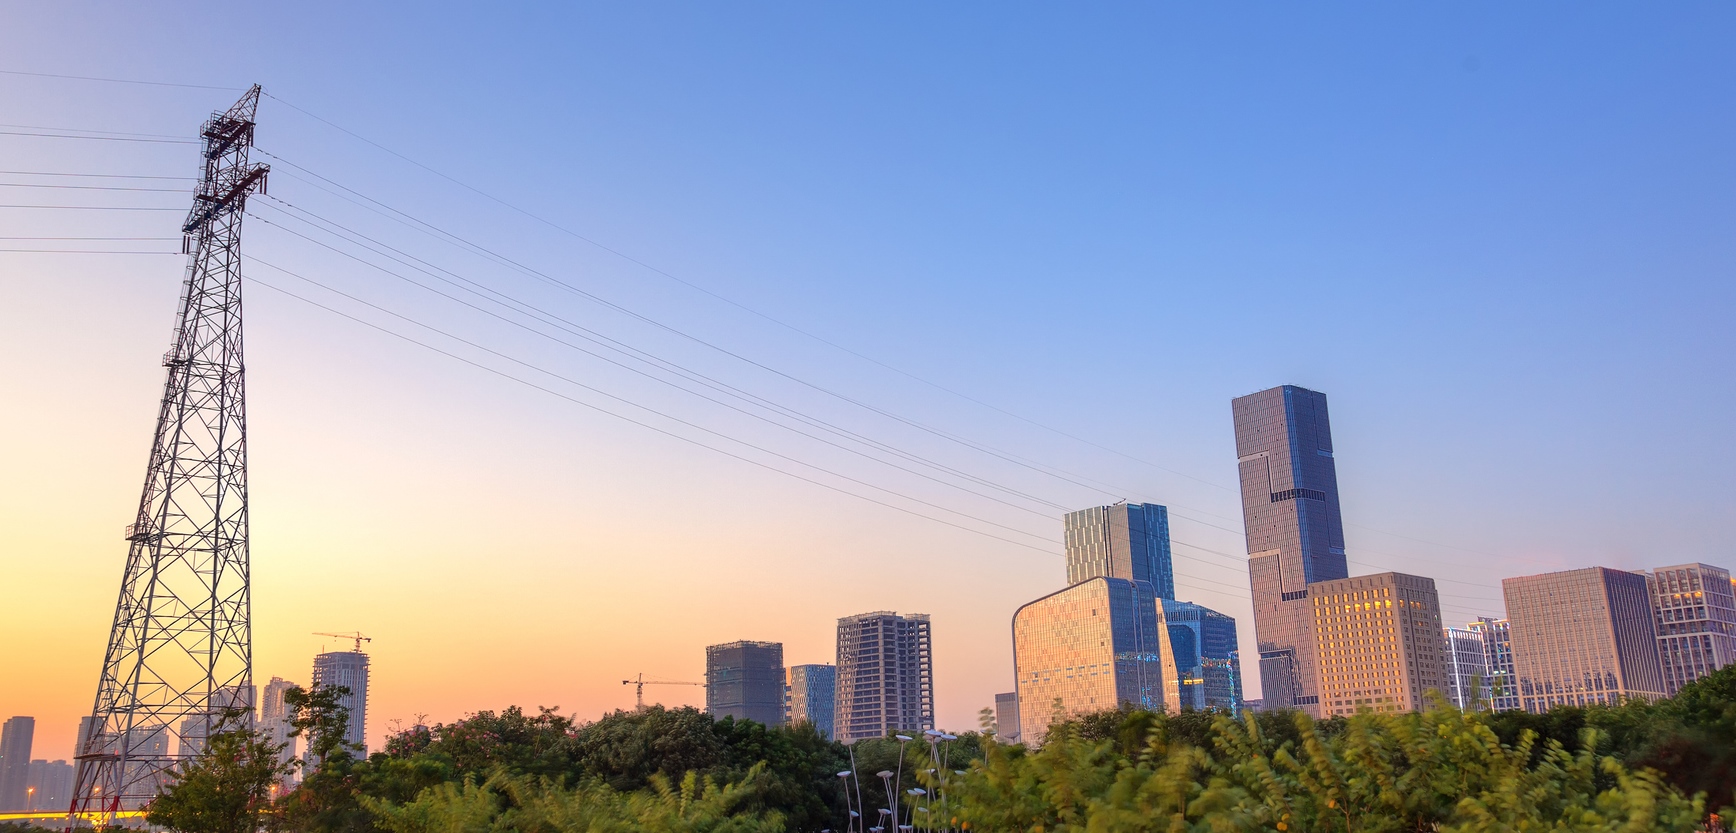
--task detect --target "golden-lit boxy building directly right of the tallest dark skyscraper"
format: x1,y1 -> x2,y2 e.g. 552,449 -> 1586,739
1307,573 -> 1448,715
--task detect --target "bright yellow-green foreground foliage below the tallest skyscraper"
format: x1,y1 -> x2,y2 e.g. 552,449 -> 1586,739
944,708 -> 1703,833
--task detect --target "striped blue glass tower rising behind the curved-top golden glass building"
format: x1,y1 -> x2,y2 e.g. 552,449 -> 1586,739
1064,503 -> 1175,599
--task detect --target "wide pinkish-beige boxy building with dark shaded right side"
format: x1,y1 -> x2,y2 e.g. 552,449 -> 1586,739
1502,567 -> 1665,713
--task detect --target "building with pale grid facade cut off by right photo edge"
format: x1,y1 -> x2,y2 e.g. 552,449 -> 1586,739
1646,564 -> 1736,696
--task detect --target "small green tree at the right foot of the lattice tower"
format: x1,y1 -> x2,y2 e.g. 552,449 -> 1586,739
146,708 -> 290,833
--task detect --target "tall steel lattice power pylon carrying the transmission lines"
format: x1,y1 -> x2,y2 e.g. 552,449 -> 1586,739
71,85 -> 267,826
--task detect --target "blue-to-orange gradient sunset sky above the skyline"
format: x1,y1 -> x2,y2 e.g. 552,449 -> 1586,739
0,2 -> 1736,758
